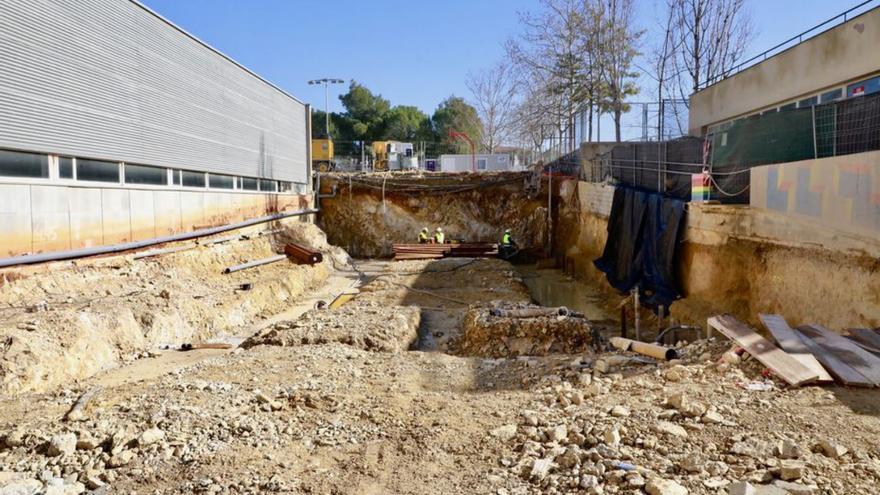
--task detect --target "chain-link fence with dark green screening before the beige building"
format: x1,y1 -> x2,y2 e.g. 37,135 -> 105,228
581,94 -> 880,203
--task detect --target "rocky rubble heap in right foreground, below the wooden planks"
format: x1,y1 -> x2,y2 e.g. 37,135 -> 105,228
488,341 -> 880,495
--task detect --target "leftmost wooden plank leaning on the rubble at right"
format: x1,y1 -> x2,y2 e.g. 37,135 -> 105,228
708,315 -> 819,386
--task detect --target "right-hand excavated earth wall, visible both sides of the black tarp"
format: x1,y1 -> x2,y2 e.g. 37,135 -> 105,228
556,181 -> 880,330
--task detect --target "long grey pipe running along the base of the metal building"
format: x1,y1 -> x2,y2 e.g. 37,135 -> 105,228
0,209 -> 318,268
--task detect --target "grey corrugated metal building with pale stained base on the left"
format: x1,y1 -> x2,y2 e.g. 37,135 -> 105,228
0,0 -> 310,257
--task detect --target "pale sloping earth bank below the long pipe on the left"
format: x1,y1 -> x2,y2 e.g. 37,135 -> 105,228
0,219 -> 336,394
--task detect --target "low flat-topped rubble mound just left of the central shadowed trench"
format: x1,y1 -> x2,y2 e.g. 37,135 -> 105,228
242,300 -> 420,352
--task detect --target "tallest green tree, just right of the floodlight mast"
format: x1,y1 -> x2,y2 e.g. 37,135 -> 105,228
339,81 -> 391,141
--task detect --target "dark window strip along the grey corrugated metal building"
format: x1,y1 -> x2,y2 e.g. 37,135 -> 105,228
0,150 -> 294,192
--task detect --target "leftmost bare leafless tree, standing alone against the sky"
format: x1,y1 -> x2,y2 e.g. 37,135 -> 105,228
465,61 -> 518,153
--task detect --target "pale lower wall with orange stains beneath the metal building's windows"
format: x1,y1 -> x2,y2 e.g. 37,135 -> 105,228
0,184 -> 311,258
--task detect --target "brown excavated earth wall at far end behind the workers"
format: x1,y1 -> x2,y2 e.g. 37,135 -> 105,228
319,173 -> 547,258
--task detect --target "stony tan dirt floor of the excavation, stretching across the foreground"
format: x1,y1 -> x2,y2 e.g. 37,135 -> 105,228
0,248 -> 880,495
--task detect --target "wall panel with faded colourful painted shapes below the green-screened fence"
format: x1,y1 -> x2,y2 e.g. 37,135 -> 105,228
750,151 -> 880,238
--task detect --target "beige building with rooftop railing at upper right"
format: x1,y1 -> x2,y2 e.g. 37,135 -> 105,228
688,7 -> 880,136
